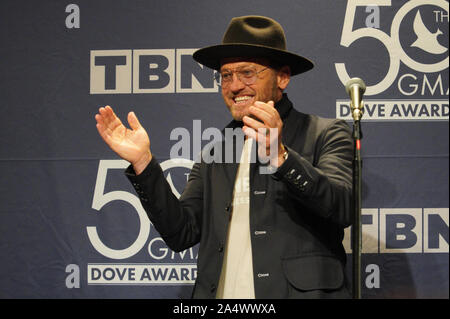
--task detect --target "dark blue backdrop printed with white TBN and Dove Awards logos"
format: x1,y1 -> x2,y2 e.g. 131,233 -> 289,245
0,0 -> 449,298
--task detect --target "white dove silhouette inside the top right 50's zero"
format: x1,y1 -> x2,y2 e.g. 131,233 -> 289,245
411,10 -> 448,54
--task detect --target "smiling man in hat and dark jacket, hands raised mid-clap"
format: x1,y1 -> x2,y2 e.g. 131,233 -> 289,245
96,16 -> 352,298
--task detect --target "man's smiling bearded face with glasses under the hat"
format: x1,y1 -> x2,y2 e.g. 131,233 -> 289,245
220,58 -> 290,121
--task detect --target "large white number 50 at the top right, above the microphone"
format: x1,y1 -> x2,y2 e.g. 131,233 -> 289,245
335,0 -> 449,95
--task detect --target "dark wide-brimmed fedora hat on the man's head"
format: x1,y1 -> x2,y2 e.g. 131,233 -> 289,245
193,16 -> 314,75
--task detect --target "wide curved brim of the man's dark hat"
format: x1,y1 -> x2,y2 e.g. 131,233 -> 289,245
192,43 -> 314,76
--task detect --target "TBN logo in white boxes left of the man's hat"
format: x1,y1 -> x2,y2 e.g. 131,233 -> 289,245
90,49 -> 219,94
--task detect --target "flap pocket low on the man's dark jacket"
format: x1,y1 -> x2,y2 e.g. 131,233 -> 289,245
282,255 -> 344,291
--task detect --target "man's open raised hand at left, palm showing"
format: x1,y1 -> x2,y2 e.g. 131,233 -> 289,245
95,106 -> 152,175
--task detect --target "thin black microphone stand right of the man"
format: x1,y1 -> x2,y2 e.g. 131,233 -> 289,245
352,107 -> 363,299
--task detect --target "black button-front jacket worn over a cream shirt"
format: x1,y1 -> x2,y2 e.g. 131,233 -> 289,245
126,95 -> 353,298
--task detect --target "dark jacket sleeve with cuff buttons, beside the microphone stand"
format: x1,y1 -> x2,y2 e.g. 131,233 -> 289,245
274,120 -> 353,227
